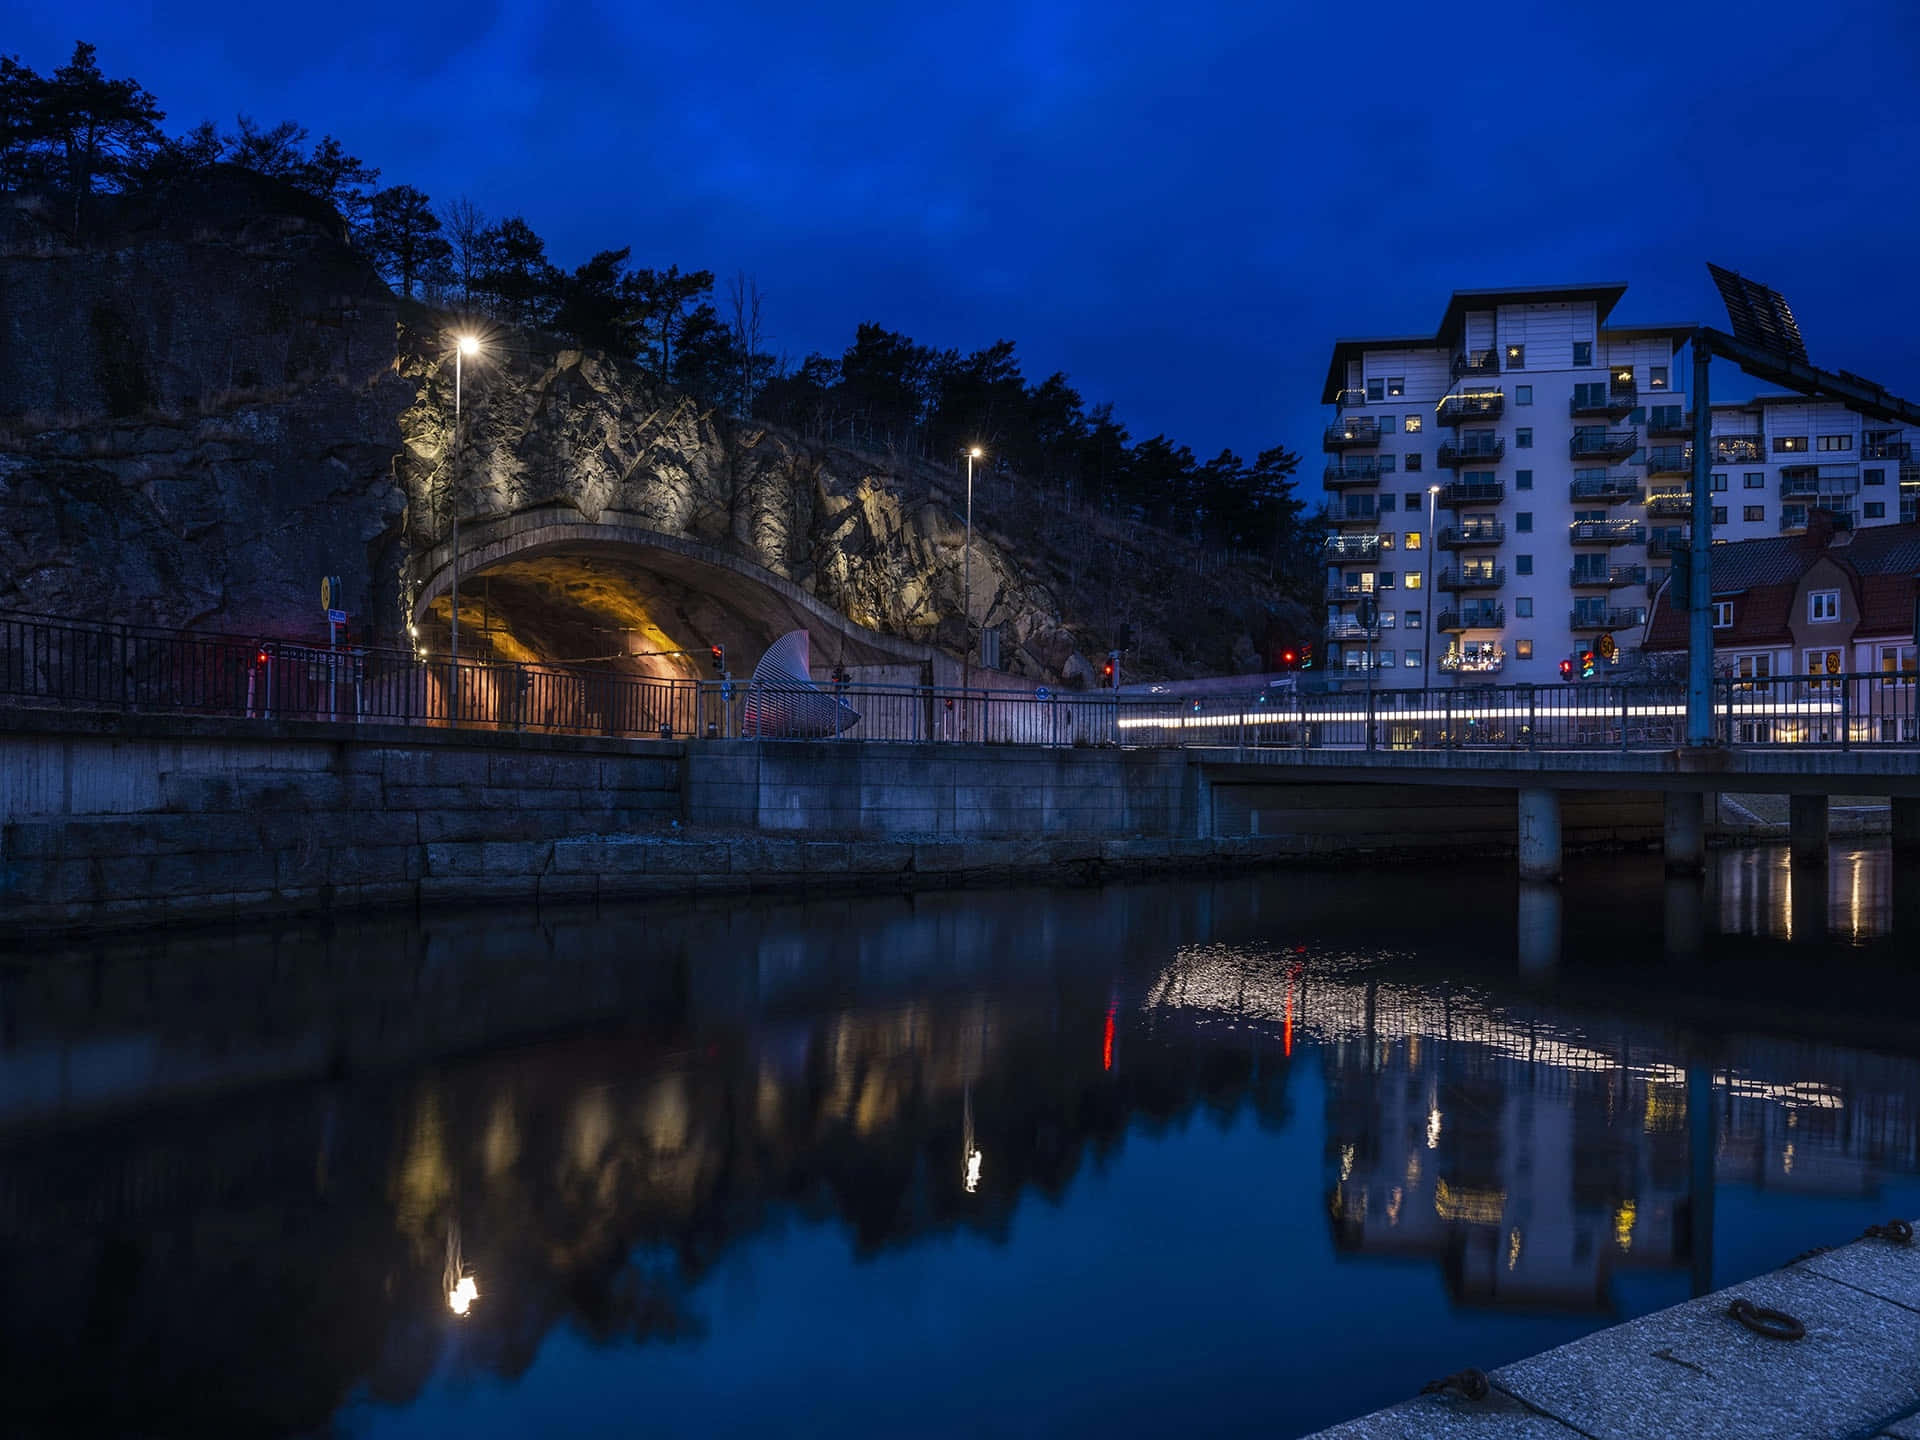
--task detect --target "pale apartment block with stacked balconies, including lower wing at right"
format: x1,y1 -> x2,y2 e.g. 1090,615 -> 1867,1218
1321,284 -> 1920,687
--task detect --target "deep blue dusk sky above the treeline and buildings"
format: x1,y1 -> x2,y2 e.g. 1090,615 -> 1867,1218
22,0 -> 1920,455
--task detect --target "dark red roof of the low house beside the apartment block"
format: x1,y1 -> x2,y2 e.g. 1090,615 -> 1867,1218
1645,511 -> 1920,651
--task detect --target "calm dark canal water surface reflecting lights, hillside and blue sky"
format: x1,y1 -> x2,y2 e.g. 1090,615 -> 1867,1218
0,852 -> 1920,1434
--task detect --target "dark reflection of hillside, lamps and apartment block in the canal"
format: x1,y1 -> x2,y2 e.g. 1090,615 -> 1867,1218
0,854 -> 1920,1430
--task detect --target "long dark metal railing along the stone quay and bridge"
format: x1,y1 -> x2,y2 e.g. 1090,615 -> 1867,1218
0,614 -> 1920,751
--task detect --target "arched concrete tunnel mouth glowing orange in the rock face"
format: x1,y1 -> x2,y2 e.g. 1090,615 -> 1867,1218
409,509 -> 947,685
